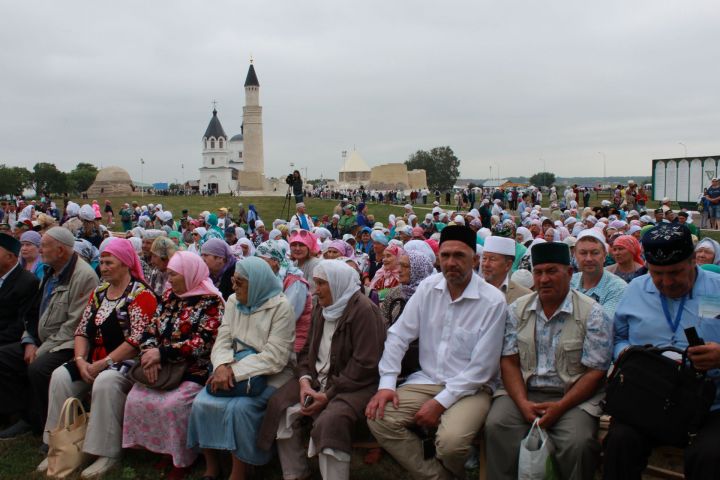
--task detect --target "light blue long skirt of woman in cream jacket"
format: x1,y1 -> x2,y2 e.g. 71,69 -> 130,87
187,387 -> 276,465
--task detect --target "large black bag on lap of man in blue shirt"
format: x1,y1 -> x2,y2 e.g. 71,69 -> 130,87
604,345 -> 715,448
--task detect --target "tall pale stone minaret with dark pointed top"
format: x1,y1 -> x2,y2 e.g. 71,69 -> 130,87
238,60 -> 265,190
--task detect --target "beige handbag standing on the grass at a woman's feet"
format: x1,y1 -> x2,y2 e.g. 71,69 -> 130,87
47,397 -> 90,478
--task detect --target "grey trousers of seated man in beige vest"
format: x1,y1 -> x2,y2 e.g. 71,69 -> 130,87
485,392 -> 600,480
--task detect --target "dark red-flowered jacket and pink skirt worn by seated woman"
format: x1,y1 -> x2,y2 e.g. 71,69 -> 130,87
123,290 -> 224,468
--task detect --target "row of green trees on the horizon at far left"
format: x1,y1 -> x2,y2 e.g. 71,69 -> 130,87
0,162 -> 98,195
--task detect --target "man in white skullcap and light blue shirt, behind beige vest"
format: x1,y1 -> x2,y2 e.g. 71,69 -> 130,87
568,228 -> 627,318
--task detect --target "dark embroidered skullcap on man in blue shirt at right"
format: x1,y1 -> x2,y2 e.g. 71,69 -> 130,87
642,222 -> 695,266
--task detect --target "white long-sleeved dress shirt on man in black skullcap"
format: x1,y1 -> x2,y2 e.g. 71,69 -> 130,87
379,273 -> 507,408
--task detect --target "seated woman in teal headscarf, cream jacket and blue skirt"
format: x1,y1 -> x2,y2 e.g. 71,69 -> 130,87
187,257 -> 295,480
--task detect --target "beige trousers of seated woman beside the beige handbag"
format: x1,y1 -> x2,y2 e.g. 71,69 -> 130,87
43,365 -> 133,458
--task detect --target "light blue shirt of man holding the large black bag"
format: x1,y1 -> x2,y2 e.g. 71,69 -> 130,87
613,268 -> 720,410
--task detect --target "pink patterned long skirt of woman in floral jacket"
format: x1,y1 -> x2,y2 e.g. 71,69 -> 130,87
123,382 -> 203,468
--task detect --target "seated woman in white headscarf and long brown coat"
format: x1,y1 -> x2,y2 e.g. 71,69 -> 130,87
258,260 -> 385,480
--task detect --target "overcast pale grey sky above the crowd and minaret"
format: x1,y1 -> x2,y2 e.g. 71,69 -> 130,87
0,0 -> 720,182
